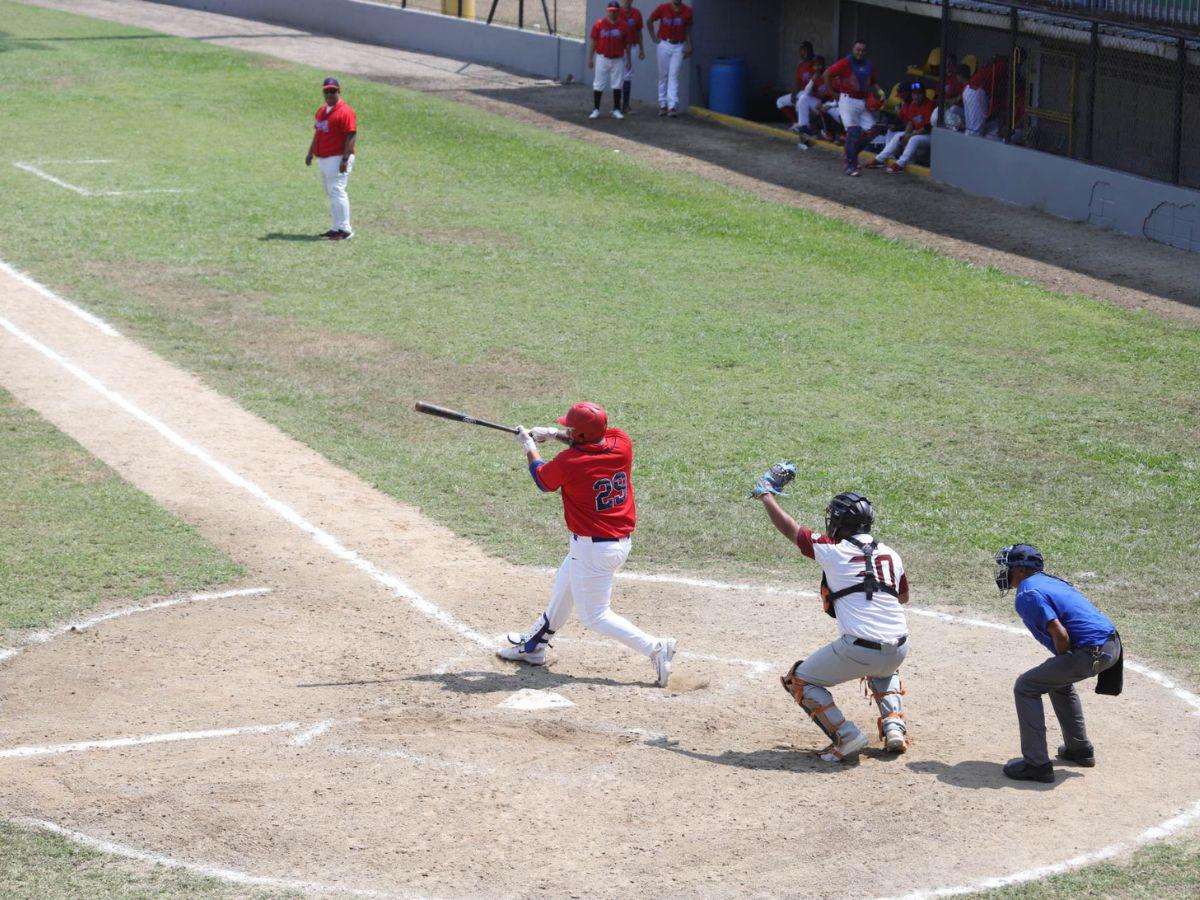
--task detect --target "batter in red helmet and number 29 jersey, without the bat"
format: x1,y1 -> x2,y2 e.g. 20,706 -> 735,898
498,403 -> 676,688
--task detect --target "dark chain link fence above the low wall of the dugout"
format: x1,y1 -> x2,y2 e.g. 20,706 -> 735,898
941,0 -> 1200,187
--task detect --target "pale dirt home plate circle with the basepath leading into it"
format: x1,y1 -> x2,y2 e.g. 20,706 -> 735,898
0,259 -> 1200,896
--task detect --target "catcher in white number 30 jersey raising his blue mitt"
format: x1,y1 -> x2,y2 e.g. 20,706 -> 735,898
750,462 -> 908,762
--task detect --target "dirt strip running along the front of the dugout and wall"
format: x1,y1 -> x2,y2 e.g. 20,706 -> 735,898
16,0 -> 1200,325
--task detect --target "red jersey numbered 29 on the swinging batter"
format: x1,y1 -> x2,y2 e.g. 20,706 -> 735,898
534,428 -> 637,538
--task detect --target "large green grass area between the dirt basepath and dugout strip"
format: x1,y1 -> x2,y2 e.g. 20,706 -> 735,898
0,0 -> 1200,896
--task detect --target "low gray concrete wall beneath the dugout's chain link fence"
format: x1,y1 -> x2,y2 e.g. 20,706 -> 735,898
932,128 -> 1200,253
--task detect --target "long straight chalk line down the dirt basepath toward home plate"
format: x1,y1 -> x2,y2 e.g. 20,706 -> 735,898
0,317 -> 498,650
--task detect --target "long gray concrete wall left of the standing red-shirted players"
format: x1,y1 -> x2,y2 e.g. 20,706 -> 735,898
157,0 -> 587,80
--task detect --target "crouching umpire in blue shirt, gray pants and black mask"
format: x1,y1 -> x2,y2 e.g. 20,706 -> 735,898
996,544 -> 1121,784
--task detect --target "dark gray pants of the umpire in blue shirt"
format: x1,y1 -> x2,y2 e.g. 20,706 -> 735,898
1013,636 -> 1121,766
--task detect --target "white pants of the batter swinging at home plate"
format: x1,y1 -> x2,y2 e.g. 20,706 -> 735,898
546,535 -> 660,656
